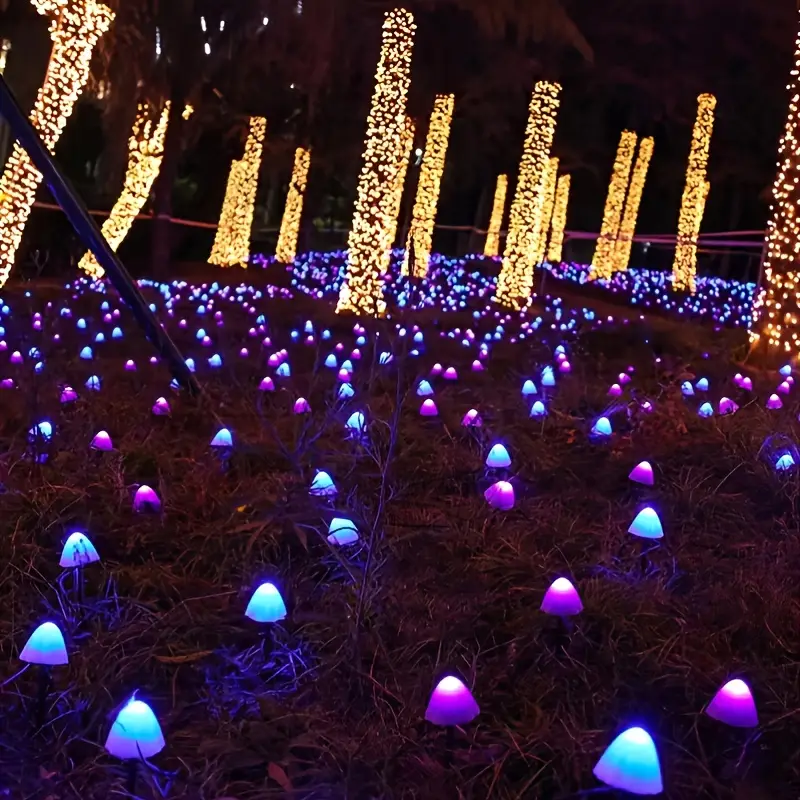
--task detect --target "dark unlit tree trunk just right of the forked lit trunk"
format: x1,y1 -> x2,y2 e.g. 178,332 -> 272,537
150,86 -> 186,277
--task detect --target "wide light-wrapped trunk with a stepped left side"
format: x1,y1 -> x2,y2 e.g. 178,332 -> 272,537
208,117 -> 267,267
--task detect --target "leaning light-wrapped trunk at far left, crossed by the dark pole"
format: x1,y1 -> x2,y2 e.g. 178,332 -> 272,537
0,0 -> 114,286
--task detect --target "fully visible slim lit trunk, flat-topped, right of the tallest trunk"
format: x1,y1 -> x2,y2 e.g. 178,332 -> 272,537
402,94 -> 455,278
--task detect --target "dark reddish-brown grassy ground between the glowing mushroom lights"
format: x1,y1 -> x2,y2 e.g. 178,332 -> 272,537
0,272 -> 800,800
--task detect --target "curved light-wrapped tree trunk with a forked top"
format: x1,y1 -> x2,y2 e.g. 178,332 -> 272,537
78,102 -> 170,279
